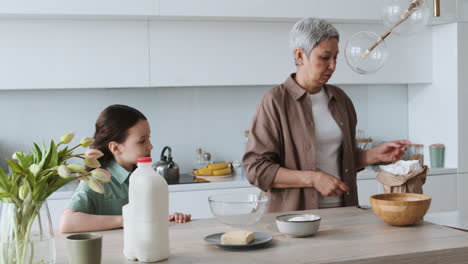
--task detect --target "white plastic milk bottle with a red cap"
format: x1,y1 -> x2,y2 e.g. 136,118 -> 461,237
122,157 -> 169,262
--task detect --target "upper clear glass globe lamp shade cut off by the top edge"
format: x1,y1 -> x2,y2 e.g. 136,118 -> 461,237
381,0 -> 431,35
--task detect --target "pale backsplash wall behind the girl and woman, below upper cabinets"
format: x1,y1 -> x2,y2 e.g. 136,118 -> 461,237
0,85 -> 408,173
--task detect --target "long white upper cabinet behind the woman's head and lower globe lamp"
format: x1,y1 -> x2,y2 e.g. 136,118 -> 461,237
150,21 -> 432,87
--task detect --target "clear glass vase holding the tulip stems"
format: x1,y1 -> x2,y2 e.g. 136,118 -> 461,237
0,201 -> 55,264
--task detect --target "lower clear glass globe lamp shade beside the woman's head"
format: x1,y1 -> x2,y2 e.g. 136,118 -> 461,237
345,31 -> 389,74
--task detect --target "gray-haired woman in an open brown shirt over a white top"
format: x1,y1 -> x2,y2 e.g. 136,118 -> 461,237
243,18 -> 410,212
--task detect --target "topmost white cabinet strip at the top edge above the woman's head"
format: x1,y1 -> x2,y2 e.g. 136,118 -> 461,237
160,0 -> 379,21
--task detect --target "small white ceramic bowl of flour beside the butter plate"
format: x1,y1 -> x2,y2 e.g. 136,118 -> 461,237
276,214 -> 321,237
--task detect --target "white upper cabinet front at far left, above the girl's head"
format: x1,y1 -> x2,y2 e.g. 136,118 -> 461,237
0,20 -> 149,89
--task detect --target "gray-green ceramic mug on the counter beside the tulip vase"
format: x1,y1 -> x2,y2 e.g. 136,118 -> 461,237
66,233 -> 102,264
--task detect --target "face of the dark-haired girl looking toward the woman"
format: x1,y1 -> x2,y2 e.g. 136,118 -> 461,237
114,120 -> 153,171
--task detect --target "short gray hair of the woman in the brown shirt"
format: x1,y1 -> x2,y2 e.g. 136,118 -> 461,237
289,17 -> 340,65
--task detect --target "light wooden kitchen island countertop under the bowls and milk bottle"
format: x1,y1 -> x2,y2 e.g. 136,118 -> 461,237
56,207 -> 468,264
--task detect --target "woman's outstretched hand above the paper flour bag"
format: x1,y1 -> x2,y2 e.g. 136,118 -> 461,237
365,140 -> 411,166
